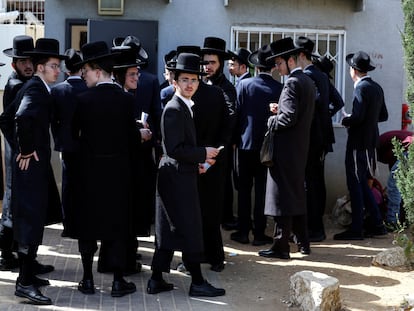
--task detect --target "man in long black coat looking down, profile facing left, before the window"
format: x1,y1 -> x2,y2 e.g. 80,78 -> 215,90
259,37 -> 315,259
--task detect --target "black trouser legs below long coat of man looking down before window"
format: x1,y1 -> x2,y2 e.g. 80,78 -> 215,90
272,214 -> 309,252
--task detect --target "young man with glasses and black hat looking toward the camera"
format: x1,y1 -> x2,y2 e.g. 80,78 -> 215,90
147,53 -> 225,297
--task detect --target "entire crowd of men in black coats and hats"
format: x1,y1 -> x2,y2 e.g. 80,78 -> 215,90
0,36 -> 388,304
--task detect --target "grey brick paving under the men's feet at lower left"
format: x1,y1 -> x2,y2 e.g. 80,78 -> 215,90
0,225 -> 233,311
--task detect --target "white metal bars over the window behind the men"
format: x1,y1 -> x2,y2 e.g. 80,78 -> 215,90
231,26 -> 346,122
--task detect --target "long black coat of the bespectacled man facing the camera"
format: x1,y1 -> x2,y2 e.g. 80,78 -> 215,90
155,95 -> 206,253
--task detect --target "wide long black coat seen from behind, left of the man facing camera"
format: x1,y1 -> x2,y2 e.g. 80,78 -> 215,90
69,83 -> 140,240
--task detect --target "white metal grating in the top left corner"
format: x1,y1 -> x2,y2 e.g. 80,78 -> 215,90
7,0 -> 45,25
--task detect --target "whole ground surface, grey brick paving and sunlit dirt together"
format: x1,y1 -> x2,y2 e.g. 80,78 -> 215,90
0,221 -> 414,311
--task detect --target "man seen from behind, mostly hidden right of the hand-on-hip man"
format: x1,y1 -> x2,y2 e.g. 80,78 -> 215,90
51,49 -> 88,236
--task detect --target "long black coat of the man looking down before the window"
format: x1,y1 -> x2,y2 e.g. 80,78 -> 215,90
265,70 -> 316,216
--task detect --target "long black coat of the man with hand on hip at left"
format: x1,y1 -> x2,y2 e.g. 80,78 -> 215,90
13,76 -> 62,245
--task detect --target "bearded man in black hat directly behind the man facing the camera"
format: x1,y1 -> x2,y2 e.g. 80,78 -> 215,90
201,37 -> 237,229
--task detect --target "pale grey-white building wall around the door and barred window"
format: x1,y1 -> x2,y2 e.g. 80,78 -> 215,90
45,0 -> 405,212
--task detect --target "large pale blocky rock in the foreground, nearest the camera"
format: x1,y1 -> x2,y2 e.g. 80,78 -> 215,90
290,271 -> 342,311
